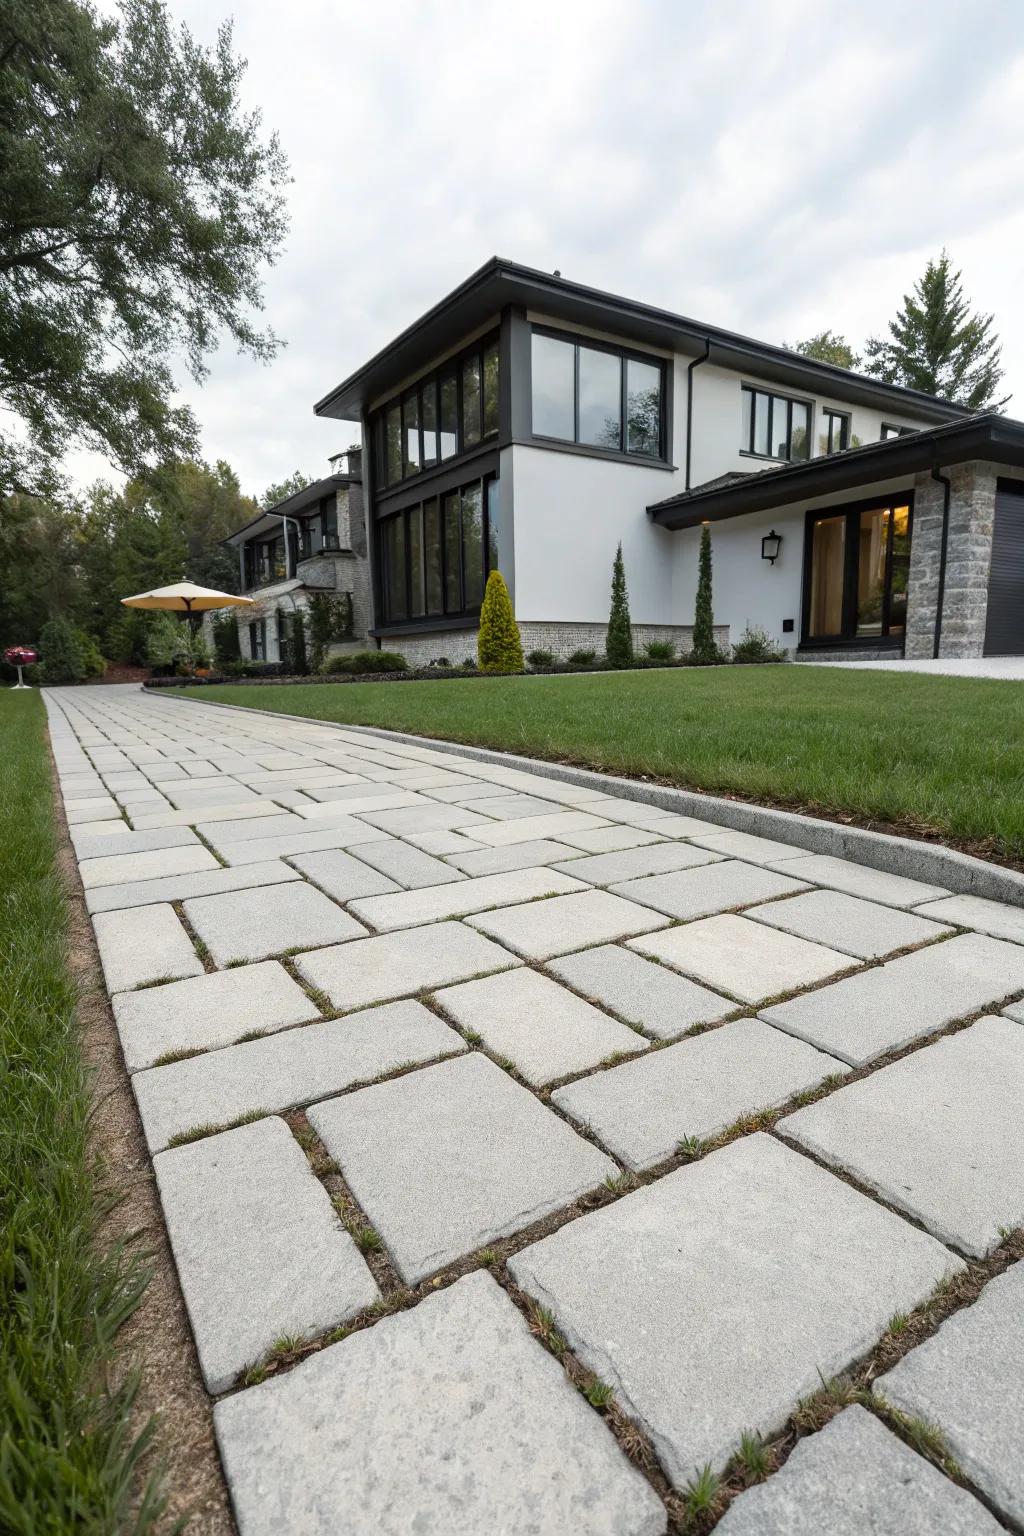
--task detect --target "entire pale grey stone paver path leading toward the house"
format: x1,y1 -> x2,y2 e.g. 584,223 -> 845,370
46,688 -> 1024,1536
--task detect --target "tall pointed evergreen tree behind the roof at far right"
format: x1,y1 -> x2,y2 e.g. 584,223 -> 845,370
866,250 -> 1009,410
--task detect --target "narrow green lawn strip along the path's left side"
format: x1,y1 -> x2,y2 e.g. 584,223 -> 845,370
0,688 -> 154,1536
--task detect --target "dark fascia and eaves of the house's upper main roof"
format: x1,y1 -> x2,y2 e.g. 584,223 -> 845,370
313,257 -> 969,422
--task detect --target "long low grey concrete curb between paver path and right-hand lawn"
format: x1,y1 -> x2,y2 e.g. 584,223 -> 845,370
152,690 -> 1024,906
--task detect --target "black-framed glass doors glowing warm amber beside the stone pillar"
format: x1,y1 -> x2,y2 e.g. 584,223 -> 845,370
803,496 -> 912,645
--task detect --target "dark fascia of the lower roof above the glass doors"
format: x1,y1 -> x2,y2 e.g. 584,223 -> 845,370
648,415 -> 1024,528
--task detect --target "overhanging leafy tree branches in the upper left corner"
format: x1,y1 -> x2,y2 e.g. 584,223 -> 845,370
0,0 -> 287,495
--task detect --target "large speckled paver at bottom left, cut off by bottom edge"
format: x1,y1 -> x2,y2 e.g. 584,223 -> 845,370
213,1273 -> 665,1536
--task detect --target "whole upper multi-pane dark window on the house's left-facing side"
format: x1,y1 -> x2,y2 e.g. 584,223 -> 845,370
372,336 -> 497,487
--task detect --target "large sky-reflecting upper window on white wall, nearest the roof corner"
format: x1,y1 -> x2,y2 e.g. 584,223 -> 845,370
531,330 -> 665,459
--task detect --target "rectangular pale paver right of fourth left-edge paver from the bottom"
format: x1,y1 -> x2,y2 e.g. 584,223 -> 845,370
295,923 -> 519,1009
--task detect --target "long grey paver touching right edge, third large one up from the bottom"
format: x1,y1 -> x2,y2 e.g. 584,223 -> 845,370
765,934 -> 1024,1066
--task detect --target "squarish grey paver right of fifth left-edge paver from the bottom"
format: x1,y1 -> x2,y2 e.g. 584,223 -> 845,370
184,882 -> 365,965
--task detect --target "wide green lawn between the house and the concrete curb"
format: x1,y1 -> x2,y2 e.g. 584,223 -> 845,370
171,665 -> 1024,860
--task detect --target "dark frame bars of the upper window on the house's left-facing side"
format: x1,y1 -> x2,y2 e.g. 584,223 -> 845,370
370,330 -> 502,496
